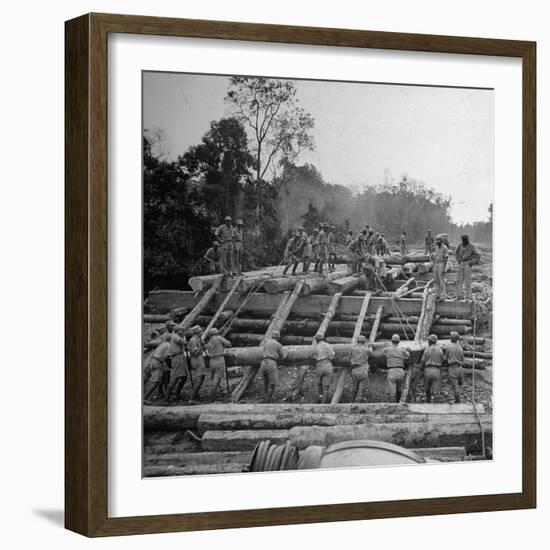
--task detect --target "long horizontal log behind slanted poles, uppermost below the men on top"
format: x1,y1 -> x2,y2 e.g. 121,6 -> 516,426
147,291 -> 473,318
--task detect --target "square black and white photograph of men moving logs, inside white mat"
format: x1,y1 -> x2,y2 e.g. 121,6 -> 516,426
143,71 -> 498,478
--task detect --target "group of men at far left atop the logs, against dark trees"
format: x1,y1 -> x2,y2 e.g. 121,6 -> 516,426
203,216 -> 243,276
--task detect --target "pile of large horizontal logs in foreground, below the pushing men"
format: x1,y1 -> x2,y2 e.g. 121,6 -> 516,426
143,403 -> 492,477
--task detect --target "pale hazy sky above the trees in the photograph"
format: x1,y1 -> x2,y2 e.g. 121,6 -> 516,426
143,73 -> 494,222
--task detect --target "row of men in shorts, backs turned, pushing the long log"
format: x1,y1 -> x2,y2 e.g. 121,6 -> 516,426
144,321 -> 470,403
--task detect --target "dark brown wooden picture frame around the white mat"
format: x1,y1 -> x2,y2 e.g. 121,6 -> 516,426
65,14 -> 536,536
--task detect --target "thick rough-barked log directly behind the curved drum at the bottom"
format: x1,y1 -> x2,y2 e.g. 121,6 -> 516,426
292,415 -> 493,450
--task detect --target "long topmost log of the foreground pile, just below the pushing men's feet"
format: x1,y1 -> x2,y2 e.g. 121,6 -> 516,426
143,403 -> 485,434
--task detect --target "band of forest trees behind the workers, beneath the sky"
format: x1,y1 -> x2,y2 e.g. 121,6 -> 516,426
143,77 -> 492,292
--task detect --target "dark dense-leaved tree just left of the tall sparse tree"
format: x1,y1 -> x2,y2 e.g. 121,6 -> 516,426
183,117 -> 254,221
